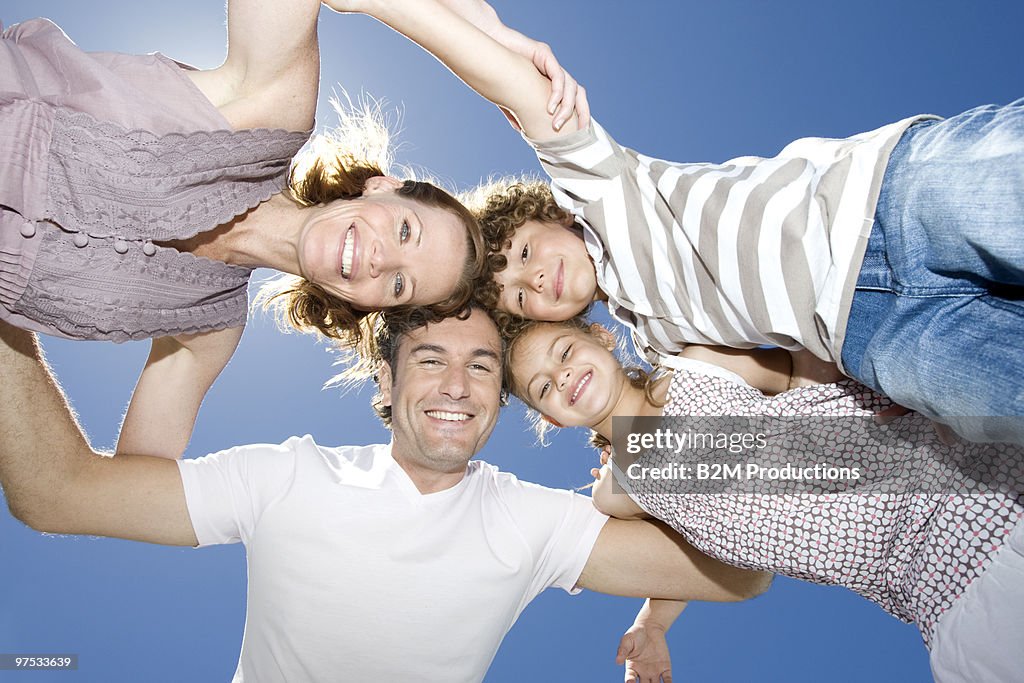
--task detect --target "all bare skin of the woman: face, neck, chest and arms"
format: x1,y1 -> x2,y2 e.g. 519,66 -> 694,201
100,0 -> 475,458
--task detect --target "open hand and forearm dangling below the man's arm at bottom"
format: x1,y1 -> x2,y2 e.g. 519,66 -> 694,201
615,599 -> 686,683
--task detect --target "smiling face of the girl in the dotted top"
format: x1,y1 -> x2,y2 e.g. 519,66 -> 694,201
509,324 -> 628,427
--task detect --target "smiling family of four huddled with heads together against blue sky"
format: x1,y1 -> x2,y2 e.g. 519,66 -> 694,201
0,0 -> 1024,681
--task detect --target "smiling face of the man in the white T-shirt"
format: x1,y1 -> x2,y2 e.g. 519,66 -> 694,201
380,310 -> 502,480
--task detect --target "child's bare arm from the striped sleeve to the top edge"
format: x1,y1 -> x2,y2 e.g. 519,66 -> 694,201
326,0 -> 578,139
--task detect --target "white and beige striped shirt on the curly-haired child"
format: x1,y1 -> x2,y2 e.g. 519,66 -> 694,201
527,117 -> 930,361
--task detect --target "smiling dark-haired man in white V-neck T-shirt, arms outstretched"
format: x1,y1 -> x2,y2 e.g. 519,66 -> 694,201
0,310 -> 768,681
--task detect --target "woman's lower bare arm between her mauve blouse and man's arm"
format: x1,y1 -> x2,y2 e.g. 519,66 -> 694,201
117,328 -> 243,459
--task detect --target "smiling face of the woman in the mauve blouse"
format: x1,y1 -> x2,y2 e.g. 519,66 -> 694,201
299,188 -> 468,310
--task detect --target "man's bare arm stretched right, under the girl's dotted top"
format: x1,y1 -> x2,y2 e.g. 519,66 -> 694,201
577,518 -> 771,602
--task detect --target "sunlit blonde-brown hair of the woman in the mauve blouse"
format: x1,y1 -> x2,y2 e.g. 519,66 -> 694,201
253,95 -> 486,348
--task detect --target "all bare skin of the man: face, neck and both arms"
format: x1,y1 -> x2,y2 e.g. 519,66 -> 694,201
0,310 -> 770,601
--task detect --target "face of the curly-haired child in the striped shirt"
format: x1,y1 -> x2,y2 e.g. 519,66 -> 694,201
495,220 -> 597,321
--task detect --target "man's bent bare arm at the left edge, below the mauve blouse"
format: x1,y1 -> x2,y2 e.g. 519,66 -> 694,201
0,323 -> 197,546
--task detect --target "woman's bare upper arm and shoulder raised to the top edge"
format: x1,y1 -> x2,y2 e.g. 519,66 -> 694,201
187,0 -> 321,131
